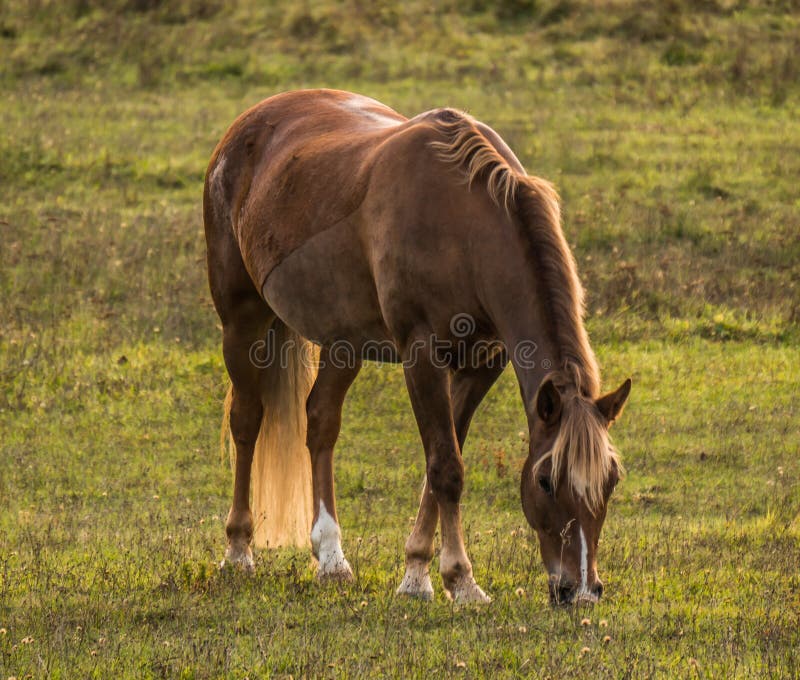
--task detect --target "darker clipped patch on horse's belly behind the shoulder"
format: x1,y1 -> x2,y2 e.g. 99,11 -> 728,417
262,221 -> 396,361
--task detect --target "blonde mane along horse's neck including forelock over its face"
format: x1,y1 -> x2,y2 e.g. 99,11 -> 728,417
431,109 -> 622,510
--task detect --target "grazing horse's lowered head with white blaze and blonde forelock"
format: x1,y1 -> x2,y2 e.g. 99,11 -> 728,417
521,379 -> 631,604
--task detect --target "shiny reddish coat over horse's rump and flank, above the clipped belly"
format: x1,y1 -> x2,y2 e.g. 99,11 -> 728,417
209,90 -> 422,288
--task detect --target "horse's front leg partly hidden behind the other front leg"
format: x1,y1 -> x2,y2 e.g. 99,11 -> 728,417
397,355 -> 507,600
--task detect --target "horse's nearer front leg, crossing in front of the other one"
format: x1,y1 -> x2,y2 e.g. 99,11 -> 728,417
404,352 -> 490,602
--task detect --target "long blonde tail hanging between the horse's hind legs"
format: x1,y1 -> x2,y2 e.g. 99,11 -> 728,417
222,319 -> 316,548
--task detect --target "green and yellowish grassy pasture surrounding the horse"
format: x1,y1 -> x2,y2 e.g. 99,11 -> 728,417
0,0 -> 800,678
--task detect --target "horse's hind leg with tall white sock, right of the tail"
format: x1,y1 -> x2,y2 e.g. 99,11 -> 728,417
306,348 -> 361,580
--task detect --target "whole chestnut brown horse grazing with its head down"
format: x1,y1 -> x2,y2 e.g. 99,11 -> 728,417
203,90 -> 630,602
